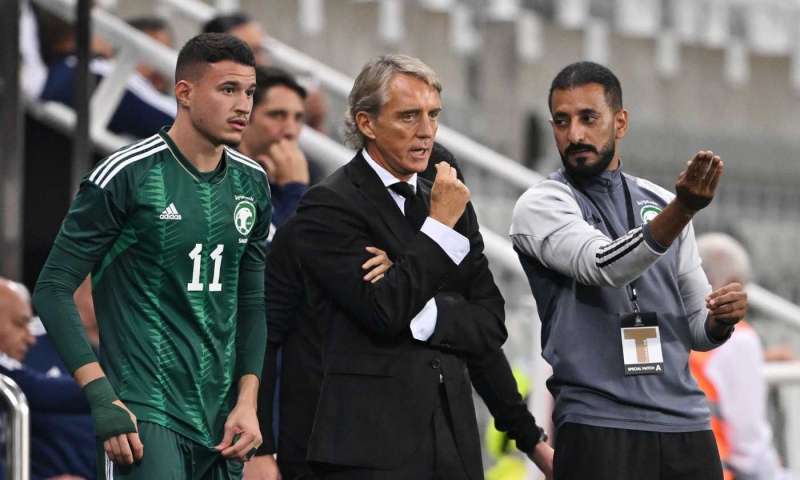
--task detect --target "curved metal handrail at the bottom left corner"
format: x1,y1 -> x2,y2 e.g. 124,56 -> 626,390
0,374 -> 30,480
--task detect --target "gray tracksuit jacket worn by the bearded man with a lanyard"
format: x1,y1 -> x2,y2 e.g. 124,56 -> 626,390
511,168 -> 718,432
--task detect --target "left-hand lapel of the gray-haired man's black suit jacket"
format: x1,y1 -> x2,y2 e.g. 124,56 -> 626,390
348,152 -> 416,242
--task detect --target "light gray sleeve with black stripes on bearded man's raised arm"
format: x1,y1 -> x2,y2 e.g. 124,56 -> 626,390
511,180 -> 666,288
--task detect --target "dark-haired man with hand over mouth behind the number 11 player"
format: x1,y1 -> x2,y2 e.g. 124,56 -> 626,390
239,66 -> 309,228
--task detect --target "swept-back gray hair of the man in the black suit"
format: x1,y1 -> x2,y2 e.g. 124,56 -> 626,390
344,54 -> 442,149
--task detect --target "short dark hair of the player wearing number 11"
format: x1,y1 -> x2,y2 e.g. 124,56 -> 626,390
175,33 -> 256,82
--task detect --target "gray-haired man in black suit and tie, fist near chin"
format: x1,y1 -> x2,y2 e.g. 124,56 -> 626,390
294,55 -> 552,480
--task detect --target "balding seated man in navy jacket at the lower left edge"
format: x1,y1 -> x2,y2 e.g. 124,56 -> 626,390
0,278 -> 94,479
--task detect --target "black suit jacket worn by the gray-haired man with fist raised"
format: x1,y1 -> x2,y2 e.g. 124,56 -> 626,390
294,154 -> 538,478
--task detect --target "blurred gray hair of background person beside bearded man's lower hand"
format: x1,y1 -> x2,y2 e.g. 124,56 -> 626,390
697,233 -> 750,289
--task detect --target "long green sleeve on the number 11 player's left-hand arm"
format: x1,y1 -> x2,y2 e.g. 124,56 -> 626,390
33,177 -> 128,373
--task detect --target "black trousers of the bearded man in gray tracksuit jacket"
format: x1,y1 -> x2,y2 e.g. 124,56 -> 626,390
553,423 -> 722,480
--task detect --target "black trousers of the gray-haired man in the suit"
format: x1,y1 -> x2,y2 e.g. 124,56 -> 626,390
312,385 -> 469,480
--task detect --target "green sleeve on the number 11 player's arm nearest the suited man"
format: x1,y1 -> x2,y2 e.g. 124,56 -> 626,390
234,182 -> 272,378
